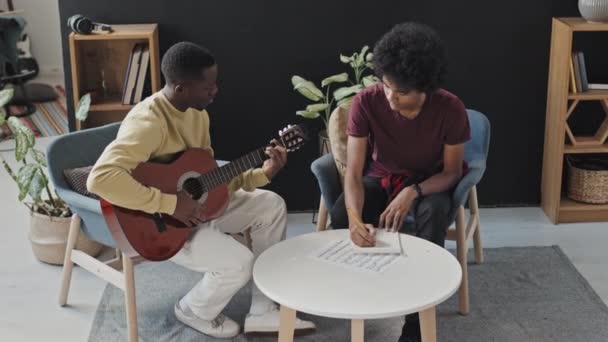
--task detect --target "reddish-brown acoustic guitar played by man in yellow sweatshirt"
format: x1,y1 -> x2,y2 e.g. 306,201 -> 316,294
100,125 -> 308,261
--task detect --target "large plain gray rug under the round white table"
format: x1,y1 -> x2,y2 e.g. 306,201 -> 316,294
89,247 -> 608,342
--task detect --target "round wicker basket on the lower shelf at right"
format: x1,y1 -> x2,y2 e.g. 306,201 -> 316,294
566,157 -> 608,204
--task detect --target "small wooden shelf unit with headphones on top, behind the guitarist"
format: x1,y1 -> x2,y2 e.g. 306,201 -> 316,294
69,24 -> 161,130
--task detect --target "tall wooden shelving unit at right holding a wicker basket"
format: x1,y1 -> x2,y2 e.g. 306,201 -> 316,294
541,18 -> 608,224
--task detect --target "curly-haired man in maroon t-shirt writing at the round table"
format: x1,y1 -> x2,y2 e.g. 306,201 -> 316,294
330,23 -> 470,342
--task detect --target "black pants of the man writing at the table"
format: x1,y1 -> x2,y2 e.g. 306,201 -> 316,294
329,177 -> 452,338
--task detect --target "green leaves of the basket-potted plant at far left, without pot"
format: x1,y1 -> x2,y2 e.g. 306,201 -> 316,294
0,89 -> 90,217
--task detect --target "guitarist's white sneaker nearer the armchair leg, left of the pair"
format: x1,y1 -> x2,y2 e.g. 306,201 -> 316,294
175,301 -> 241,338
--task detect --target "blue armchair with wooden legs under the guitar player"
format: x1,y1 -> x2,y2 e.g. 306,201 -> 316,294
47,123 -> 138,342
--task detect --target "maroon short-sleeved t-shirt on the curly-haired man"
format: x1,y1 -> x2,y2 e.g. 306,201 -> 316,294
347,84 -> 471,178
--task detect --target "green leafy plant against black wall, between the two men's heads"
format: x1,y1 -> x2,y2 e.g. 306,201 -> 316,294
291,45 -> 379,127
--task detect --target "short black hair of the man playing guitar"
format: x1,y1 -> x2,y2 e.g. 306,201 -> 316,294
161,42 -> 215,83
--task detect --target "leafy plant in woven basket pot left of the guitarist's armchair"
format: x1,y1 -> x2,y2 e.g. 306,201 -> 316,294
0,89 -> 103,265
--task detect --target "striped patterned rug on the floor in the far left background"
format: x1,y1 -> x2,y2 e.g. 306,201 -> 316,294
2,85 -> 68,139
